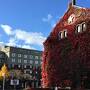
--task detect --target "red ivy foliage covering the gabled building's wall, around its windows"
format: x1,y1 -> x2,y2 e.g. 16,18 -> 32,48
42,4 -> 90,87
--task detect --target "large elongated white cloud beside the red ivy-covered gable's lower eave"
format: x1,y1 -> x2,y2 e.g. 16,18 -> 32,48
15,29 -> 46,45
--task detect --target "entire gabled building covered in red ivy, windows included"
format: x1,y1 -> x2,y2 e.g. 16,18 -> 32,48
42,2 -> 90,88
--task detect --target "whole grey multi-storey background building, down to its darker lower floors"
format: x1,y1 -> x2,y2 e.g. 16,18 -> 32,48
0,46 -> 42,87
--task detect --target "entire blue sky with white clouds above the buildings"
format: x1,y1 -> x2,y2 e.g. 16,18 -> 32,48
0,0 -> 90,50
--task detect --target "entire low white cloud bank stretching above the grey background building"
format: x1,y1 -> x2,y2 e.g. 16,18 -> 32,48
1,24 -> 46,49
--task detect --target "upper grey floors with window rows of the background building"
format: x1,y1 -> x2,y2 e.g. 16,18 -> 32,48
2,46 -> 42,72
